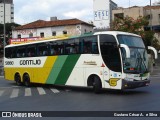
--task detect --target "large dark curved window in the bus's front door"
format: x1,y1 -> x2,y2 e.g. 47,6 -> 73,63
100,35 -> 121,72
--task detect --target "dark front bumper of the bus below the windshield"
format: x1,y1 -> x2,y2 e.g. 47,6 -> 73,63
122,79 -> 150,89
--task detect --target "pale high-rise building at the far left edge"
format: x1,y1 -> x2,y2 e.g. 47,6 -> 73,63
0,0 -> 14,24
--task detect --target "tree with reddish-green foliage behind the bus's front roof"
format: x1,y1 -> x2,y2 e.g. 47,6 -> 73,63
111,16 -> 160,49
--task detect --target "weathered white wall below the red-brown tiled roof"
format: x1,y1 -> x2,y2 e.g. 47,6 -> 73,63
12,25 -> 93,38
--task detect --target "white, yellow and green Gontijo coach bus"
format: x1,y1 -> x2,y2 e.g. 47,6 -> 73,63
4,31 -> 157,93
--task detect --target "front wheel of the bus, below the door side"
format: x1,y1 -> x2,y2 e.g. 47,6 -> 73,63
93,76 -> 102,93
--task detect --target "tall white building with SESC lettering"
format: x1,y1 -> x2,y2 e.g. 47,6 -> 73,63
93,0 -> 117,29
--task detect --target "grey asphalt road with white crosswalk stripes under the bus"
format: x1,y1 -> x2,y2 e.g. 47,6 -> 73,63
0,56 -> 160,120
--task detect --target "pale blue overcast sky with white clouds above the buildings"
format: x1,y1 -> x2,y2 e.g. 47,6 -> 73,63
14,0 -> 156,24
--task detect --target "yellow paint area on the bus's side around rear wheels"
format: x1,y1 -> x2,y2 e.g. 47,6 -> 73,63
5,56 -> 58,84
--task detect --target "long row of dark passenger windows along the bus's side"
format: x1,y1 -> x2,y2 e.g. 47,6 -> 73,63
5,36 -> 99,58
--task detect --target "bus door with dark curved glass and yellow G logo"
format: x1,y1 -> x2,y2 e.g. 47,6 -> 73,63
100,35 -> 122,89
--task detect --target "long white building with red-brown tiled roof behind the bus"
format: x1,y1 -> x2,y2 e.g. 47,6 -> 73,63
12,17 -> 94,38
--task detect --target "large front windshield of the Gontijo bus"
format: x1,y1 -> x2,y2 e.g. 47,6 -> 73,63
117,35 -> 148,74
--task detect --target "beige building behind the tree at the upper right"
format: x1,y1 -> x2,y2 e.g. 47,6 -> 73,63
112,6 -> 160,32
